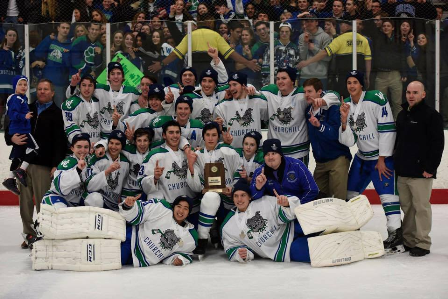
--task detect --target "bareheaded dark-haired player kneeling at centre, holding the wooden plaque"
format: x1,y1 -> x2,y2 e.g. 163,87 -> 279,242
187,122 -> 242,255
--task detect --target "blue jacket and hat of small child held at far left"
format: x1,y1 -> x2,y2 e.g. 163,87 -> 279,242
6,75 -> 31,135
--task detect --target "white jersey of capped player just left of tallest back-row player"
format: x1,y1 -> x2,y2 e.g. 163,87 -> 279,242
213,95 -> 268,148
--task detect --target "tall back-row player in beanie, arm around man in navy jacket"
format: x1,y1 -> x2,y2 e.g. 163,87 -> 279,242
261,67 -> 339,165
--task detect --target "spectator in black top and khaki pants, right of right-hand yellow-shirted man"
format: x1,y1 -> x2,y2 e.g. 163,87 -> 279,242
372,19 -> 407,119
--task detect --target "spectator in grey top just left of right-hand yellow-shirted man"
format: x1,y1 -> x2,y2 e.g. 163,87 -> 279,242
299,14 -> 331,90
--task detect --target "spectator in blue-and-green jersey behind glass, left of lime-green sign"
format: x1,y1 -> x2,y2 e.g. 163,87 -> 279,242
70,23 -> 103,76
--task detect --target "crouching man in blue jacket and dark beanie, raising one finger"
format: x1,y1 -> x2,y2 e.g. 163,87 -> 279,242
250,139 -> 319,204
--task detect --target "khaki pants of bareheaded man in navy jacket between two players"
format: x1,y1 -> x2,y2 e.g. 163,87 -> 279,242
313,156 -> 350,200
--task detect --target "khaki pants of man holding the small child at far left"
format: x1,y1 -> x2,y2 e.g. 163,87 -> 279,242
19,164 -> 51,236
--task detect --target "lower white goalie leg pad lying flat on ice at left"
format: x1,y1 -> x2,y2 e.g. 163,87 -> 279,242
31,239 -> 121,271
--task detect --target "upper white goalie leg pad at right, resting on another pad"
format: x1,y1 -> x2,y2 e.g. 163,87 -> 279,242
294,196 -> 373,235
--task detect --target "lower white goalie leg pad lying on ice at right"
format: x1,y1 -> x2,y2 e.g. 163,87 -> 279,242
308,231 -> 384,267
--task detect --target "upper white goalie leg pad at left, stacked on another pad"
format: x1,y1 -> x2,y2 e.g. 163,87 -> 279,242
37,205 -> 126,241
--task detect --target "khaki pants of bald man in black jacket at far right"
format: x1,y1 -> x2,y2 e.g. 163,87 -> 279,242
397,176 -> 434,250
